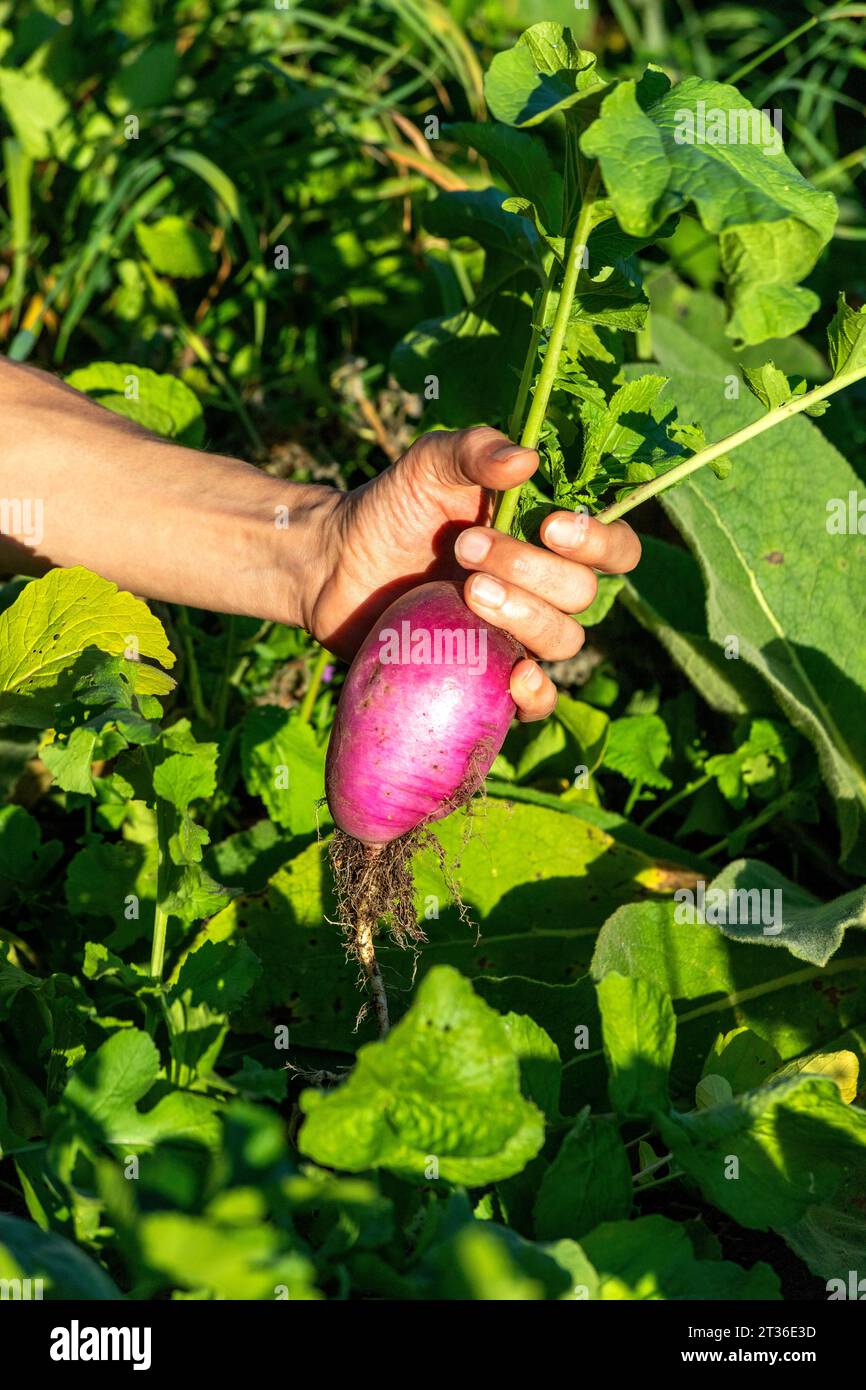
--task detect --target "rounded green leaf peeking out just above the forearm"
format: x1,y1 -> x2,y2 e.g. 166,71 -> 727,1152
65,361 -> 204,449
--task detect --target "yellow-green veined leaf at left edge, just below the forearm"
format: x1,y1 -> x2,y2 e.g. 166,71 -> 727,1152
0,566 -> 175,728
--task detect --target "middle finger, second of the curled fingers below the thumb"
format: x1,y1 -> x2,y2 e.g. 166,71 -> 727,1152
455,525 -> 598,613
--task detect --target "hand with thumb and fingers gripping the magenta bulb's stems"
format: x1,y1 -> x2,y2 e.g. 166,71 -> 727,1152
306,428 -> 641,720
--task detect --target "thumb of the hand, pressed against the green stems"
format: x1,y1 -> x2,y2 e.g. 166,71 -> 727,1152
406,425 -> 538,503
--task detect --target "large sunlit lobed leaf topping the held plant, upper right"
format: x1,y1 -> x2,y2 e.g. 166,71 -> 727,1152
581,78 -> 835,344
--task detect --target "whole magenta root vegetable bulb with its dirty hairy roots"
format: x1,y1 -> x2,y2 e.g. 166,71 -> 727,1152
325,581 -> 525,1033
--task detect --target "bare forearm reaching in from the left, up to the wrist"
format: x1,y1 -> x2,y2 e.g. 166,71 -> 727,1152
0,361 -> 336,626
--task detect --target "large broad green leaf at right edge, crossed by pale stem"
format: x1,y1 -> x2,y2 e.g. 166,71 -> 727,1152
644,320 -> 866,856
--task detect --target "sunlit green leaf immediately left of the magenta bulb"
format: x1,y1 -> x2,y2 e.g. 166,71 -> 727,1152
240,705 -> 329,835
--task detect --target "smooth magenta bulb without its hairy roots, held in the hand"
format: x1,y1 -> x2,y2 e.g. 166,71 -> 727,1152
325,581 -> 525,845
